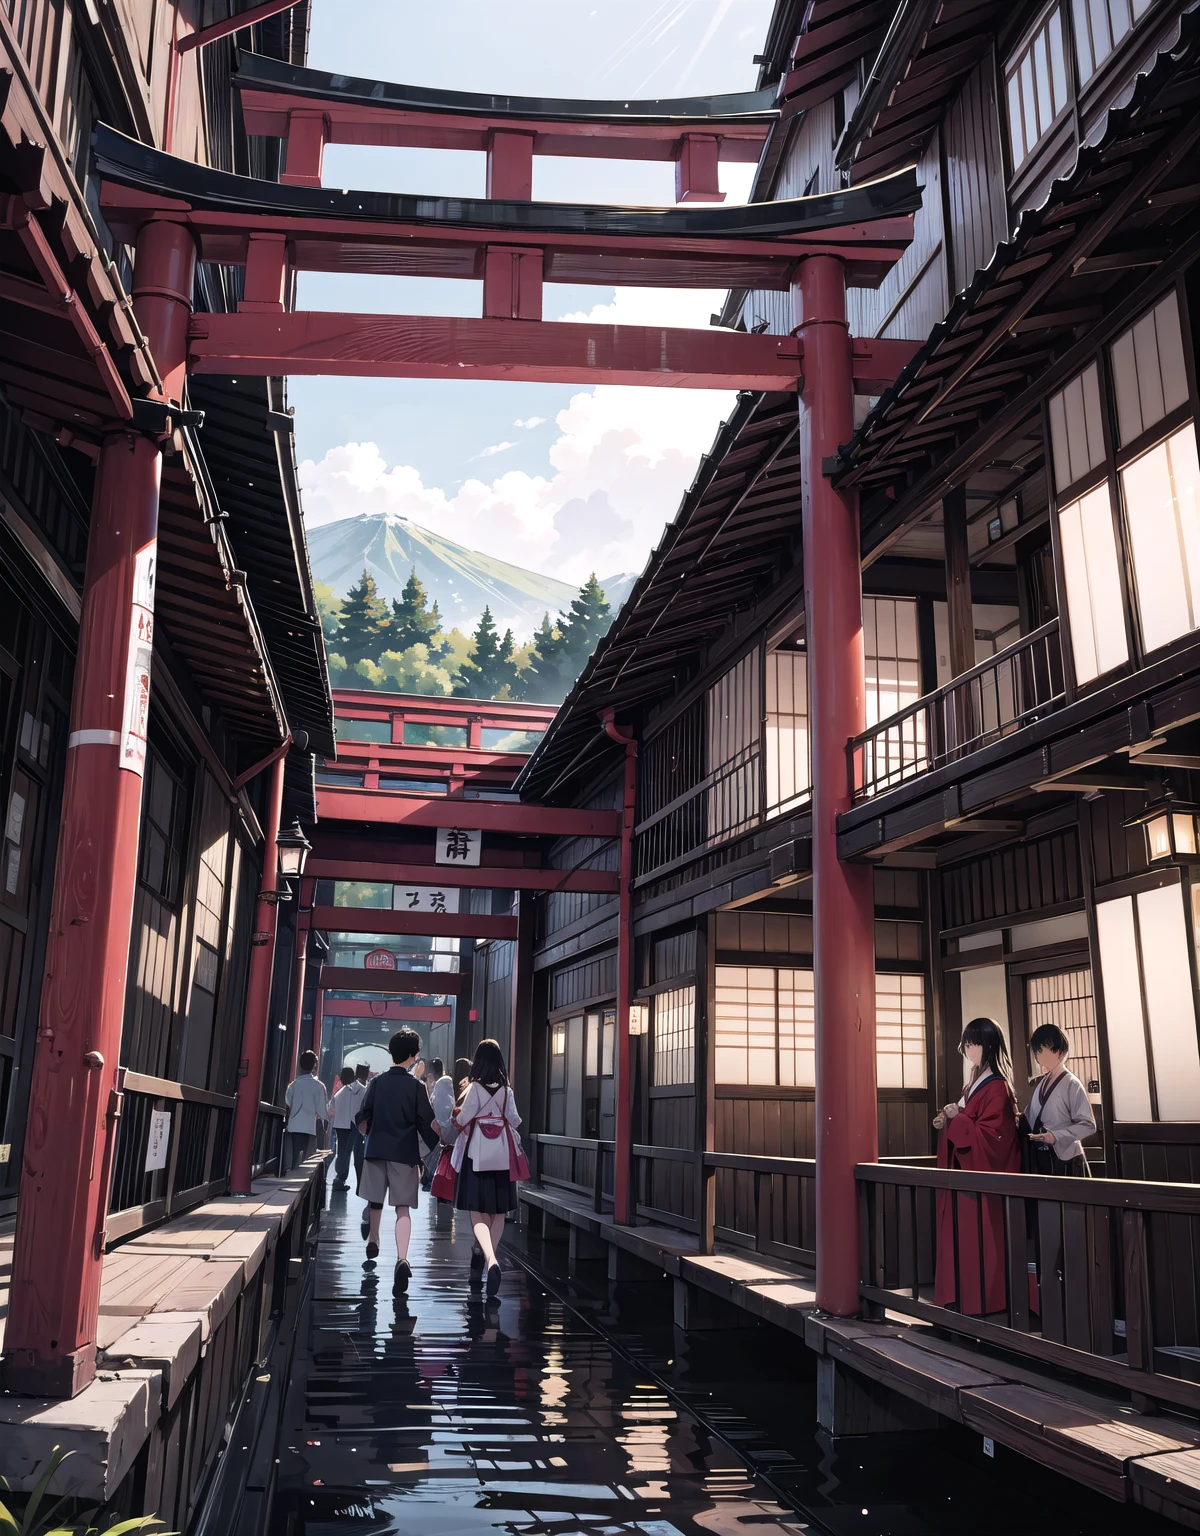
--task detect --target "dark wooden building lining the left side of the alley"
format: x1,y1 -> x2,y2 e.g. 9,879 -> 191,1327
0,0 -> 333,1241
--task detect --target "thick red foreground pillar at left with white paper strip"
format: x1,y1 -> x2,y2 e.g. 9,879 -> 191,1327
3,224 -> 195,1398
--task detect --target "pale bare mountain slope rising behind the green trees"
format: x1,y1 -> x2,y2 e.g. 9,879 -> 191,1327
307,513 -> 635,637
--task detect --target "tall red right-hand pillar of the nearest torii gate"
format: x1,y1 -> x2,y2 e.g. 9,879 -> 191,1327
793,257 -> 879,1316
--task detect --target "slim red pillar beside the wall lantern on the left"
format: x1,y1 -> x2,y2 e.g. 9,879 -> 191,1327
229,753 -> 287,1195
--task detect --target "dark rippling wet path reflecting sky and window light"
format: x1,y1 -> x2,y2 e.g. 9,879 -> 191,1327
267,1190 -> 1177,1536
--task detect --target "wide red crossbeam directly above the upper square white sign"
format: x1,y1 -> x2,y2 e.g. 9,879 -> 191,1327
317,783 -> 621,837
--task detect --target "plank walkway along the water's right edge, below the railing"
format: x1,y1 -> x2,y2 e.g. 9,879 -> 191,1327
521,1186 -> 1200,1530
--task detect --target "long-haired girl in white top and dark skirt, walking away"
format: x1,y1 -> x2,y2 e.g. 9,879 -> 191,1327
455,1040 -> 521,1301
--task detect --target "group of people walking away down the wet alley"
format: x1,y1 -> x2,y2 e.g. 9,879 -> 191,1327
286,1029 -> 521,1301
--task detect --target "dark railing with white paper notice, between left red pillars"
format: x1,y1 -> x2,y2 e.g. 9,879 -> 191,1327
104,1072 -> 235,1243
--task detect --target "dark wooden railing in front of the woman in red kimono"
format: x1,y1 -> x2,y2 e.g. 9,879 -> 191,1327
856,1163 -> 1200,1410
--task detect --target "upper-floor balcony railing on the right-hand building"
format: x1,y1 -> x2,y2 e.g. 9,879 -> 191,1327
847,619 -> 1065,802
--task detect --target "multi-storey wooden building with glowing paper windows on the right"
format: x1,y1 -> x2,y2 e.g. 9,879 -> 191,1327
519,0 -> 1200,1252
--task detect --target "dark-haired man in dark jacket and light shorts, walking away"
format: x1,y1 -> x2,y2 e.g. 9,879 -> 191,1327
358,1029 -> 441,1296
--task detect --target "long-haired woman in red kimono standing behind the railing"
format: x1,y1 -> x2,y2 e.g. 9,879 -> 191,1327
933,1018 -> 1020,1316
